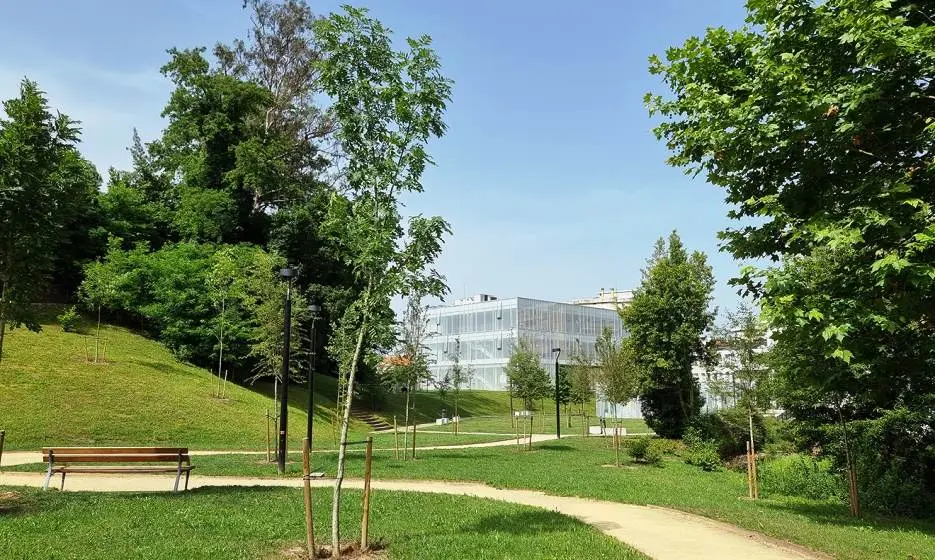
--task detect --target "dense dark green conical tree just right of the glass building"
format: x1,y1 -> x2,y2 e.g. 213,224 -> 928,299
620,232 -> 714,438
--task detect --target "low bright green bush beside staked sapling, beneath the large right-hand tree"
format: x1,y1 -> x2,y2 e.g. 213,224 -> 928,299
758,455 -> 846,500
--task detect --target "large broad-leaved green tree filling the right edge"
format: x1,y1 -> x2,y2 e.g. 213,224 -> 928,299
647,0 -> 935,516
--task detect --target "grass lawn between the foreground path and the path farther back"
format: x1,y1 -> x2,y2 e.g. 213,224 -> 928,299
168,438 -> 935,560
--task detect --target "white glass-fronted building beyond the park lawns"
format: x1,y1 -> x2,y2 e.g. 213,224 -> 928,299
426,294 -> 624,391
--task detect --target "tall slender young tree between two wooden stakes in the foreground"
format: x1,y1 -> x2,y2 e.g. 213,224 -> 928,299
315,7 -> 451,556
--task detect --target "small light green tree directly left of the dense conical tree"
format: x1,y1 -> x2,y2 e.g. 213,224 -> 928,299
594,327 -> 642,416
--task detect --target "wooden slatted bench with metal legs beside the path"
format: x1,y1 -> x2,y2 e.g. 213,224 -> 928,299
42,447 -> 194,492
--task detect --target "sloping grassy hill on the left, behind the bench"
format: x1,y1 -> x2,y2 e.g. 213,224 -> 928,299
0,312 -> 528,450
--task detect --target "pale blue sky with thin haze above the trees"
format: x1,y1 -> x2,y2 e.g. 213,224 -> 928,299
0,0 -> 744,314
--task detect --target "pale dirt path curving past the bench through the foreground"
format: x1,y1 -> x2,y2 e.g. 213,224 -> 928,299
0,473 -> 826,560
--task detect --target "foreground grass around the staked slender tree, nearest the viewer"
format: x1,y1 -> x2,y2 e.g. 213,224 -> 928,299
0,487 -> 646,560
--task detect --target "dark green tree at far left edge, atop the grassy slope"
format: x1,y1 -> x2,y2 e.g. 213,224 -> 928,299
0,80 -> 100,366
